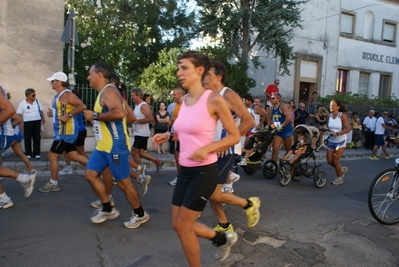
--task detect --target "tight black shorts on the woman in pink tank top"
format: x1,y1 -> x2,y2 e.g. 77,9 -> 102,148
172,162 -> 218,211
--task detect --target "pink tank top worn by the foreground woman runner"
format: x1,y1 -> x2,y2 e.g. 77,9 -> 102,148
173,90 -> 217,167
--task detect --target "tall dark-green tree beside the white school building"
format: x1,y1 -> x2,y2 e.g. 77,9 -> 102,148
197,0 -> 307,75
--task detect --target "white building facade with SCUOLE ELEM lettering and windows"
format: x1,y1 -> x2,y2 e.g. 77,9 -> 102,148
251,0 -> 399,107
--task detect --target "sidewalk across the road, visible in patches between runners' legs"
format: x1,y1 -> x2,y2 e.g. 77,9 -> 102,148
3,148 -> 399,172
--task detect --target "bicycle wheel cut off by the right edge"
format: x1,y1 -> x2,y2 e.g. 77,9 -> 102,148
368,168 -> 399,225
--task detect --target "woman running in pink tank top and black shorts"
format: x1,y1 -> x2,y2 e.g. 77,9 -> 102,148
153,51 -> 240,266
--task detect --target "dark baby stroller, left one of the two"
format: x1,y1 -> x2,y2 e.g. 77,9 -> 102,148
233,127 -> 275,175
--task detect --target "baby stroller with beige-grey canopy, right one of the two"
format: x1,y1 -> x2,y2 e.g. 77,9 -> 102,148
278,124 -> 327,188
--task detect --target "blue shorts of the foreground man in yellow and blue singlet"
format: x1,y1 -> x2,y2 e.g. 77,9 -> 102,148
86,149 -> 130,181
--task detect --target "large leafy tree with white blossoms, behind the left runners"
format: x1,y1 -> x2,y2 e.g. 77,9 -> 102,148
65,0 -> 195,83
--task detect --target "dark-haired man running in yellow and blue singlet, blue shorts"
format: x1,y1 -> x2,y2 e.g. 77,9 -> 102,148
84,63 -> 150,228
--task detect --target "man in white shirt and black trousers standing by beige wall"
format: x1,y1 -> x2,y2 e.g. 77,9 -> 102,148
17,88 -> 46,159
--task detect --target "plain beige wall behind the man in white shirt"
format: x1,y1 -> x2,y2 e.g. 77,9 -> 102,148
0,0 -> 64,142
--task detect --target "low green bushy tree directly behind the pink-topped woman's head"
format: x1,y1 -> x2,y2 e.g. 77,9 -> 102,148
140,47 -> 255,100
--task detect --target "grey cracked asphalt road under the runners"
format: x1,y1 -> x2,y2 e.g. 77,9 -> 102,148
0,158 -> 399,267
